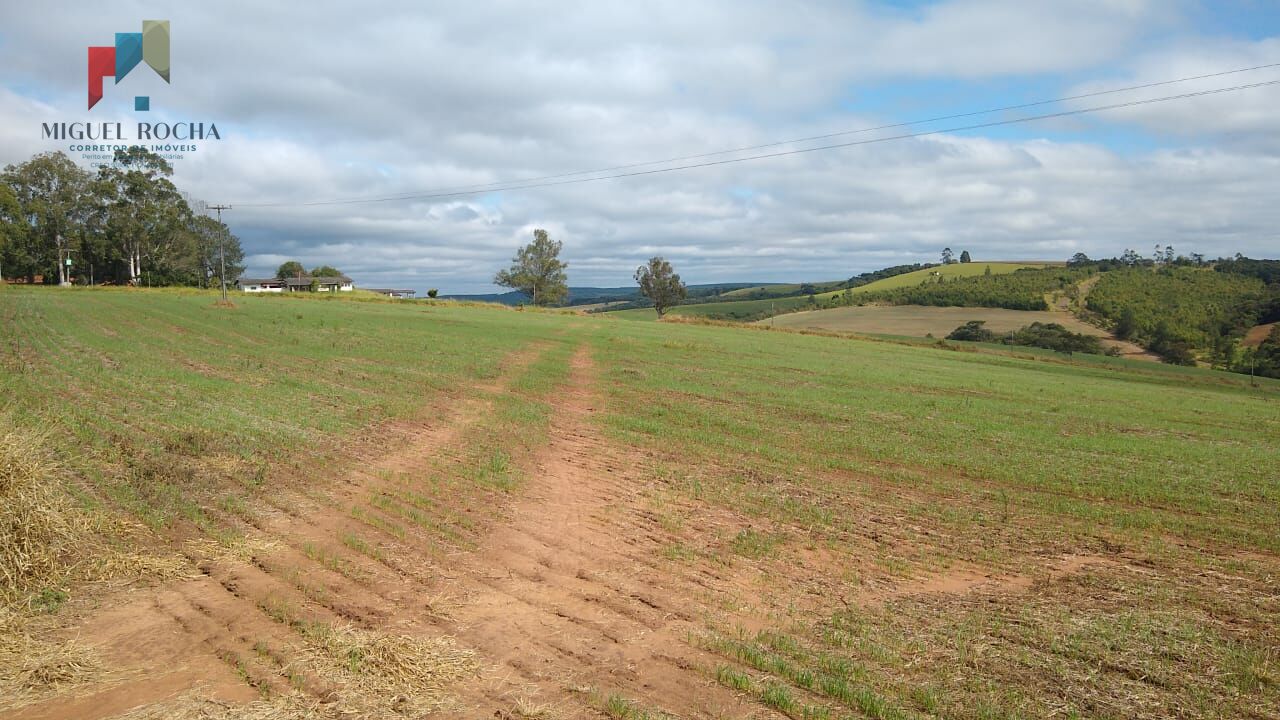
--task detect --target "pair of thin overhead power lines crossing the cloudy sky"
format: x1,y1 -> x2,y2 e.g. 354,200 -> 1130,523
239,75 -> 1280,208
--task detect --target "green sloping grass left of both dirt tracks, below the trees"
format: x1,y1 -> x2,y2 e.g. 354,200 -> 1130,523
0,283 -> 556,530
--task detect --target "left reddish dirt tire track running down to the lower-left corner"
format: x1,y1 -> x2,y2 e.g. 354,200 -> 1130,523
0,343 -> 548,720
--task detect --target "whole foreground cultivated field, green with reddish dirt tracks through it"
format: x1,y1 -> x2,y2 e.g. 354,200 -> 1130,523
0,285 -> 1280,720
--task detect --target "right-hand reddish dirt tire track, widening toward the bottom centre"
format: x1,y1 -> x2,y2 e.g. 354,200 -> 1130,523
445,346 -> 759,717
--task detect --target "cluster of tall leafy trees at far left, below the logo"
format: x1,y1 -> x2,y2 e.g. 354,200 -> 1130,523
0,147 -> 244,287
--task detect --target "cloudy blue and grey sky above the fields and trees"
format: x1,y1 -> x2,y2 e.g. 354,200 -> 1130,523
0,0 -> 1280,293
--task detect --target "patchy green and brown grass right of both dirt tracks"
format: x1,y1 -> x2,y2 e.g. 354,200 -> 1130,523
594,301 -> 1280,717
